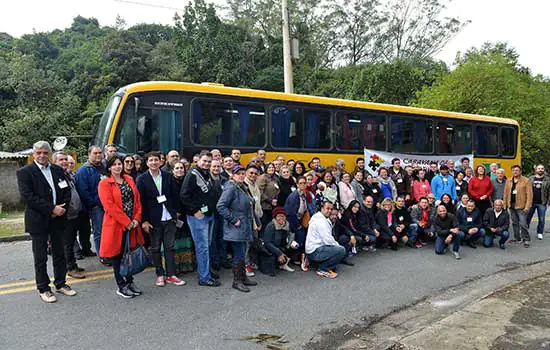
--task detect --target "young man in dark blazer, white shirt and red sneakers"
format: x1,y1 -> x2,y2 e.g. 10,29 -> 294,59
136,152 -> 185,287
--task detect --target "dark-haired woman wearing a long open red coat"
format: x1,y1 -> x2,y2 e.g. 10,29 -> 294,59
98,156 -> 143,298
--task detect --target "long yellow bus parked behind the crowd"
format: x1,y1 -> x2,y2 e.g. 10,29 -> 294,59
94,82 -> 521,174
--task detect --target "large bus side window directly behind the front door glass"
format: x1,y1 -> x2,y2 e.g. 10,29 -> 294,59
192,101 -> 265,147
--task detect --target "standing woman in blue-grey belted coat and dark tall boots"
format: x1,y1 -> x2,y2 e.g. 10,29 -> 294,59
216,165 -> 261,292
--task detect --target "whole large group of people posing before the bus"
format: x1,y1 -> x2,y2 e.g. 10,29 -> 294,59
17,141 -> 550,302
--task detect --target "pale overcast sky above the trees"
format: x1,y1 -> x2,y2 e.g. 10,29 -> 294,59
0,0 -> 550,76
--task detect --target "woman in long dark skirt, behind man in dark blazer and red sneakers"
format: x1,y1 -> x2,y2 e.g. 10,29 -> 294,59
172,161 -> 196,275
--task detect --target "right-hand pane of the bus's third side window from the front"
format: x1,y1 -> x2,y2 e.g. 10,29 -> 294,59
304,109 -> 331,149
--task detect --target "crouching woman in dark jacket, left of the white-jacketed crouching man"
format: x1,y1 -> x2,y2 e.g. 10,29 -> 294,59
259,207 -> 298,276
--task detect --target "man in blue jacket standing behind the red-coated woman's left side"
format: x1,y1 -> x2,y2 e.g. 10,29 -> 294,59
76,146 -> 105,262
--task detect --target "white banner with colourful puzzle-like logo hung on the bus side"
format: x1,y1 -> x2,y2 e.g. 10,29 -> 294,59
365,148 -> 474,176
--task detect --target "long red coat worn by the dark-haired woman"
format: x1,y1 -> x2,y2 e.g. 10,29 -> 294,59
98,175 -> 143,258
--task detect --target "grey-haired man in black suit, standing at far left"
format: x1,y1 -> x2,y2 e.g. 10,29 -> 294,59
17,141 -> 76,303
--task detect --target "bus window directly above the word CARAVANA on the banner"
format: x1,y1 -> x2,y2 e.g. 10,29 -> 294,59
391,117 -> 433,153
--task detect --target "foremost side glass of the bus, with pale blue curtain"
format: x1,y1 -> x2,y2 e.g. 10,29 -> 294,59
115,105 -> 182,153
